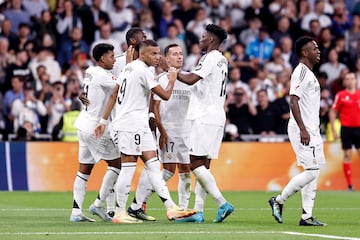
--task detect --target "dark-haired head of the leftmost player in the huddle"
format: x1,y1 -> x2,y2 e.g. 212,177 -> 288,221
93,43 -> 115,70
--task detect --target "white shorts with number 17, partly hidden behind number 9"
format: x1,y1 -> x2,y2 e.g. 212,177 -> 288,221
158,136 -> 190,164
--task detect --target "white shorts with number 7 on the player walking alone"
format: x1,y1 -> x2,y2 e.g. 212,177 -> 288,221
288,125 -> 325,169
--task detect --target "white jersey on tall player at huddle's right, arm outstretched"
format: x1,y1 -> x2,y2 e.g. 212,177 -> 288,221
187,50 -> 228,126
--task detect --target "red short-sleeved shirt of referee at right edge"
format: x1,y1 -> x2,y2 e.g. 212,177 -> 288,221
332,90 -> 360,127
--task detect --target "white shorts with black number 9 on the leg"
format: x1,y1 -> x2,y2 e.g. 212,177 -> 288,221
117,131 -> 156,156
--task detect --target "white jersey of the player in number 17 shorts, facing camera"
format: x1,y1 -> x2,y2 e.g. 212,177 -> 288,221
154,73 -> 191,136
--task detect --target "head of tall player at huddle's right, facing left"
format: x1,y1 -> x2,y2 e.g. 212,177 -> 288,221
200,24 -> 227,50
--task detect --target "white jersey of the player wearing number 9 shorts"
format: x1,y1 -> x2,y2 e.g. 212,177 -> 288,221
113,59 -> 159,132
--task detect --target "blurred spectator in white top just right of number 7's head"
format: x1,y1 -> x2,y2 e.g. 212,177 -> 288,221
319,48 -> 346,84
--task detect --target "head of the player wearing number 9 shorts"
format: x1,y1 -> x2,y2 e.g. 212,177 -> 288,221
139,39 -> 160,67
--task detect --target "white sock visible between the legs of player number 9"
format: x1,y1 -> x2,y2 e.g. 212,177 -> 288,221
130,169 -> 154,210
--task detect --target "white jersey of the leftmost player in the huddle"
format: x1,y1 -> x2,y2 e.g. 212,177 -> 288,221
74,66 -> 116,133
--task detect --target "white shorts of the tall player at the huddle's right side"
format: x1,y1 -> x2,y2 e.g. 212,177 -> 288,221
189,120 -> 224,159
